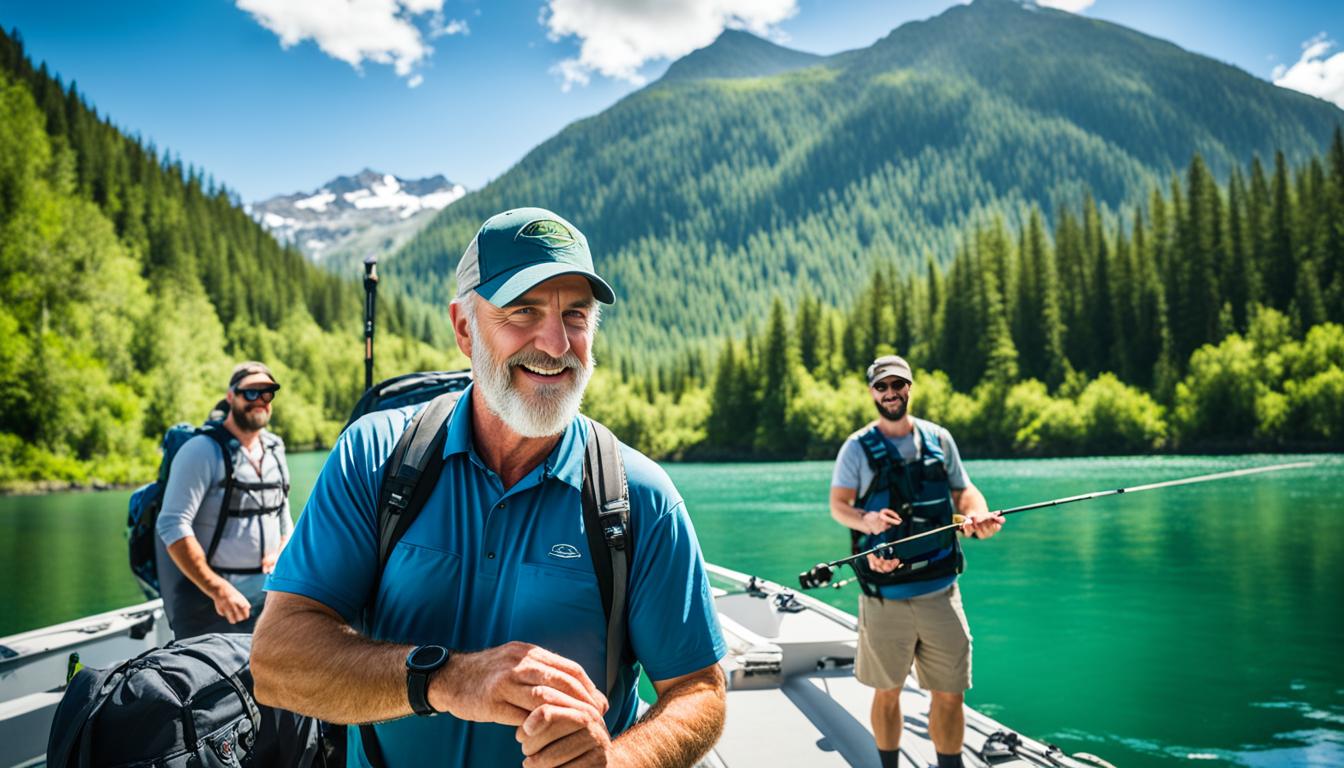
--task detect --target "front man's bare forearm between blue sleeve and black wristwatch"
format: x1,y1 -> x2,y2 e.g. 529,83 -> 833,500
251,593 -> 411,724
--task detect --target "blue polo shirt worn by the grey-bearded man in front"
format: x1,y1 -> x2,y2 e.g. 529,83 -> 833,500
266,389 -> 724,768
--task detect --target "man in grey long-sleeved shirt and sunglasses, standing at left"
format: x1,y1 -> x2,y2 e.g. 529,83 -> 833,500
156,362 -> 294,639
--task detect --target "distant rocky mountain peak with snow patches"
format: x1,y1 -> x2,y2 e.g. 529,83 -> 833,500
247,168 -> 466,270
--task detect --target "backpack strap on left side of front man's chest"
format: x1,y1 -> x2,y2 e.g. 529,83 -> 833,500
372,391 -> 461,596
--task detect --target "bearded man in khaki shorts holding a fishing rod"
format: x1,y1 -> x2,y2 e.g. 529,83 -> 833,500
831,355 -> 1003,768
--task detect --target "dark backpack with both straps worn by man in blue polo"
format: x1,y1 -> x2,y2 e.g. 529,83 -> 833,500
338,371 -> 633,768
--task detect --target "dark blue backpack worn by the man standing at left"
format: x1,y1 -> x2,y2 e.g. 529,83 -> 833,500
126,425 -> 234,599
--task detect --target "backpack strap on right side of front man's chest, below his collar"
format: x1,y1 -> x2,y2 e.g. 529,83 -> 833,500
583,418 -> 634,695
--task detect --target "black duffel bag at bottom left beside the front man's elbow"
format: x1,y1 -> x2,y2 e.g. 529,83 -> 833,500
47,635 -> 321,768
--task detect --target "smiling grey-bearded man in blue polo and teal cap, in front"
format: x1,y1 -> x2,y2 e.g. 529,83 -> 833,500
253,208 -> 724,768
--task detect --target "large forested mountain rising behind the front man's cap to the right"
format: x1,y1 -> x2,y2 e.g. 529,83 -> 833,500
388,0 -> 1344,370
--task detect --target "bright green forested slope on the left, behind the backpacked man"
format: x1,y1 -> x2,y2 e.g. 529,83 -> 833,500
0,34 -> 453,490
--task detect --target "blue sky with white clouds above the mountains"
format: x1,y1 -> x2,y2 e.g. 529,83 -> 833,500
0,0 -> 1344,200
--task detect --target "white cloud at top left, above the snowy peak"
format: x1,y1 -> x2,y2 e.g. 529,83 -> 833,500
235,0 -> 444,80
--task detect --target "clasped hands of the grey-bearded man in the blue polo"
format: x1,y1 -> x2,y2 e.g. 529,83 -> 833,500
430,642 -> 612,768
